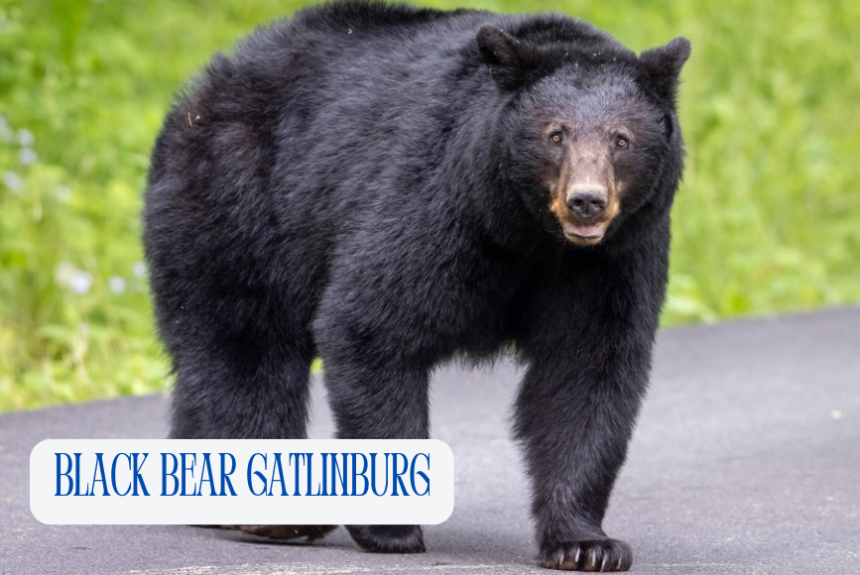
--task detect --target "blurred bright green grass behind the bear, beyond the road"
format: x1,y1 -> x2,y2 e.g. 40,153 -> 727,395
0,0 -> 860,411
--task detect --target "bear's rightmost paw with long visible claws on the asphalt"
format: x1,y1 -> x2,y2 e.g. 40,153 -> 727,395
540,539 -> 633,572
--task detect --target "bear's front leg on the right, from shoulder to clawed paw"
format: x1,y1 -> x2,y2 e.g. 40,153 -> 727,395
516,254 -> 665,571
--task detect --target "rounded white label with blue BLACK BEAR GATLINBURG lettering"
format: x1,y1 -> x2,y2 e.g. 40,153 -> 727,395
30,439 -> 454,525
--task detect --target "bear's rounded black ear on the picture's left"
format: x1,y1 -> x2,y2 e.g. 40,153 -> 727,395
478,26 -> 536,91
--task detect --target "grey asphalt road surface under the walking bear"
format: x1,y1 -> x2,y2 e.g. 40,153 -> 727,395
0,309 -> 860,575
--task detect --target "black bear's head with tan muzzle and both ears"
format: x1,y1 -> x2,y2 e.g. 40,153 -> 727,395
477,23 -> 690,246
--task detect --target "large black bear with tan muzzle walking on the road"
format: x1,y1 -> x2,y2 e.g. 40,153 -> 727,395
144,1 -> 690,571
